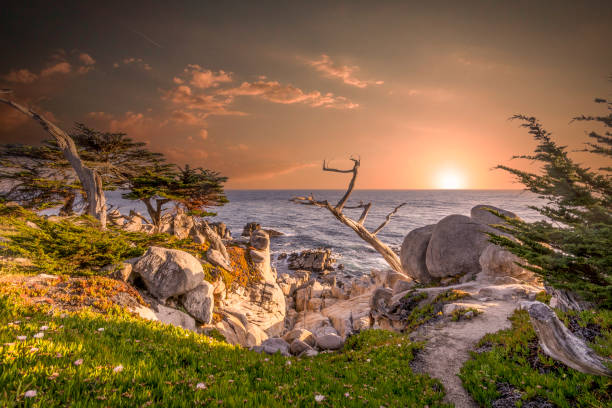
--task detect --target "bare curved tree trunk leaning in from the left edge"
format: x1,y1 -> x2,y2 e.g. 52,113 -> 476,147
0,90 -> 106,229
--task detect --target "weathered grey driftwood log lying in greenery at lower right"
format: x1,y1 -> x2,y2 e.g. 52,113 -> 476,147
527,302 -> 612,377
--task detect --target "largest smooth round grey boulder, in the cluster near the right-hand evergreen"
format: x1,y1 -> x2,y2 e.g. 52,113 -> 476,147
426,214 -> 495,278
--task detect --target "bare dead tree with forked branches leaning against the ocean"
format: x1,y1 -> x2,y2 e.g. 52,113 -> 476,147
291,158 -> 406,275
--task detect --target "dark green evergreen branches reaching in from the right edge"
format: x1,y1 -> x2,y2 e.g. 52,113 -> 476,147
491,99 -> 612,308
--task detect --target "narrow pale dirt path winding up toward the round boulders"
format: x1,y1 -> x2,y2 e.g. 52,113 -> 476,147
411,300 -> 517,408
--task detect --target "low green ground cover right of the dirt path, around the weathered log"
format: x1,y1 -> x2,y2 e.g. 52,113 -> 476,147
460,311 -> 612,407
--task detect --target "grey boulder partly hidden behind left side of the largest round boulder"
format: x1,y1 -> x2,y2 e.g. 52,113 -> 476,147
400,225 -> 435,283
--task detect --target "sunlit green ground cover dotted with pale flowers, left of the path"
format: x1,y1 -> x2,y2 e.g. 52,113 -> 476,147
0,295 -> 447,407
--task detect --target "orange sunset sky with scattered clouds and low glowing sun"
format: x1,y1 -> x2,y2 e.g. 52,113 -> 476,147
0,1 -> 612,189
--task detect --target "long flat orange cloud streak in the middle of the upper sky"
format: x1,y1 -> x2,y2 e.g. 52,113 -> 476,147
219,81 -> 359,109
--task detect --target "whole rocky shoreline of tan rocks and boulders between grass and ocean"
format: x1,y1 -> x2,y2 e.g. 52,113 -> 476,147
97,205 -> 543,364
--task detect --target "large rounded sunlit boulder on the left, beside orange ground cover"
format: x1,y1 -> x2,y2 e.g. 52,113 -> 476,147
132,247 -> 204,301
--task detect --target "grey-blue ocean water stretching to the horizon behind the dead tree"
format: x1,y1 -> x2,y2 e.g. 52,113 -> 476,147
108,190 -> 540,274
